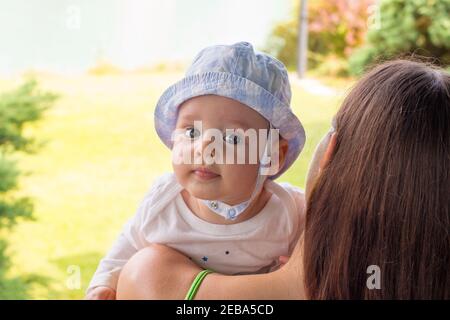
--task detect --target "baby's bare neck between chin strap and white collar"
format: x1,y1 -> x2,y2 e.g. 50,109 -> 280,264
181,188 -> 272,224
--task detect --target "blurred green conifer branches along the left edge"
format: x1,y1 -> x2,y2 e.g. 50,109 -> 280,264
0,80 -> 57,299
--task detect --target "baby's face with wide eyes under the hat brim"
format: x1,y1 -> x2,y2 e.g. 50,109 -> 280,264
173,95 -> 269,205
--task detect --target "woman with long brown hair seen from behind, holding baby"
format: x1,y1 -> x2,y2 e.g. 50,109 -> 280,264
117,60 -> 450,299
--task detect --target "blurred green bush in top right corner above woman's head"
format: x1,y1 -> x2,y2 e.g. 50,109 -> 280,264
349,0 -> 450,74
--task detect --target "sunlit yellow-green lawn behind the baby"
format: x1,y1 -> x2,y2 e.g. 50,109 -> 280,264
0,73 -> 350,299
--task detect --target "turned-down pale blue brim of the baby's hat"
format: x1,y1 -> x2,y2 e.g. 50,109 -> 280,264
154,72 -> 305,179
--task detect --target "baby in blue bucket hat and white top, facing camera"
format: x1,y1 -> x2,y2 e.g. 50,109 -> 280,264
87,42 -> 305,299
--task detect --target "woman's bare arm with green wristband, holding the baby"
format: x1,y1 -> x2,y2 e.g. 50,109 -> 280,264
117,245 -> 303,300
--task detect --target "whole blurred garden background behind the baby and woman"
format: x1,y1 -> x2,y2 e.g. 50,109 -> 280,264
0,0 -> 450,299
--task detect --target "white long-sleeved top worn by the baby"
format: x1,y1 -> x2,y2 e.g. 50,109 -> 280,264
88,174 -> 305,291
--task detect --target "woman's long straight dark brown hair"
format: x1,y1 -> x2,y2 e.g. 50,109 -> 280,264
304,60 -> 450,299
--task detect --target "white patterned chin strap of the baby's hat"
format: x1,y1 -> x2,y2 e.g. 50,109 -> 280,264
202,126 -> 278,220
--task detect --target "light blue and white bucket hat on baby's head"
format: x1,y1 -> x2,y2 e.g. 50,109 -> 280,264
154,42 -> 305,179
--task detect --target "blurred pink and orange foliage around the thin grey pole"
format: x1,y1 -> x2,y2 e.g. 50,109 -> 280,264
265,0 -> 375,73
